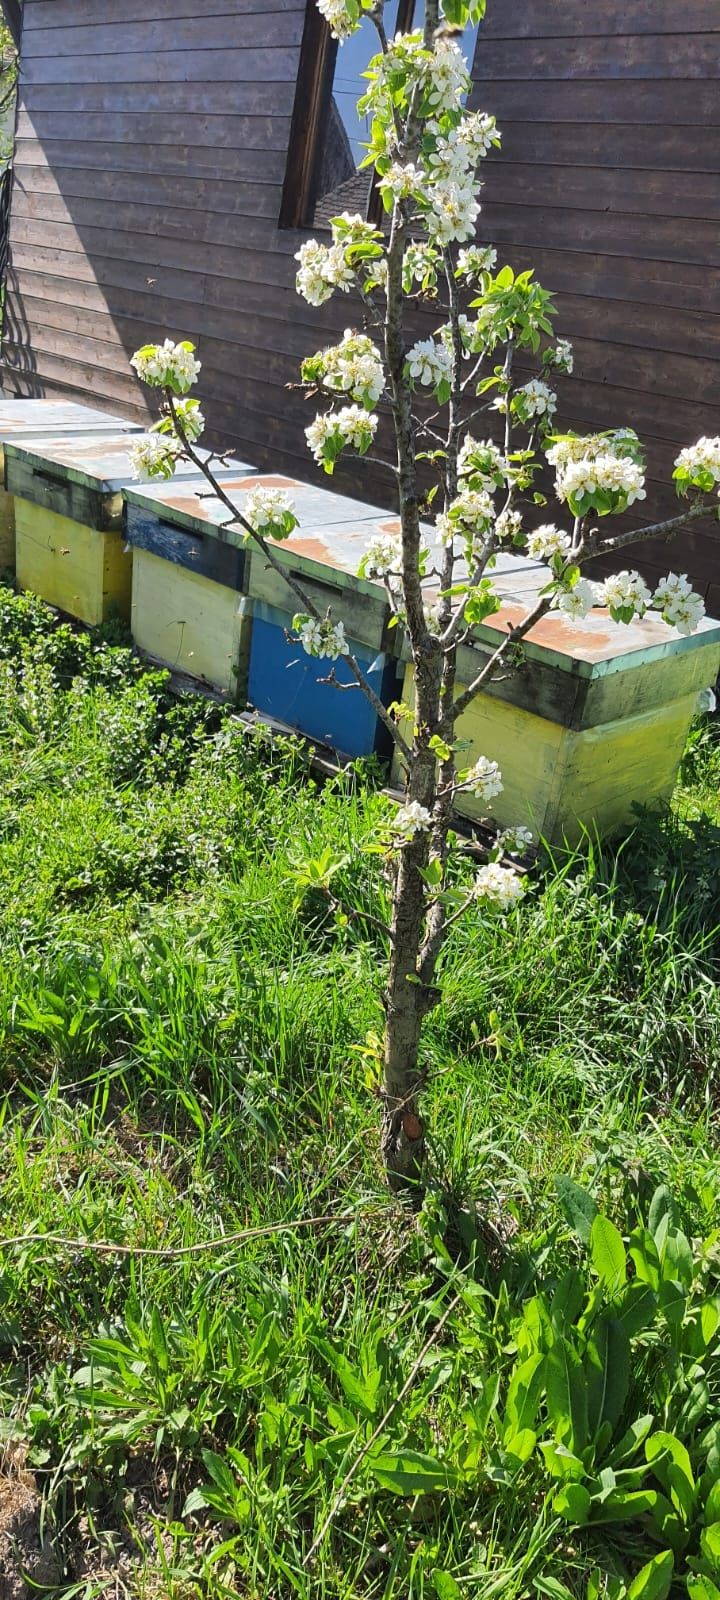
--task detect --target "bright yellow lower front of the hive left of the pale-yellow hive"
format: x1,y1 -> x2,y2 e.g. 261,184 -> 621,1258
14,499 -> 111,627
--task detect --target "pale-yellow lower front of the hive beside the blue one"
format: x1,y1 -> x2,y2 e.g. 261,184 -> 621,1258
131,549 -> 250,694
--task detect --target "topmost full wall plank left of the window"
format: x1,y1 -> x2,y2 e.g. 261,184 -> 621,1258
22,10 -> 302,55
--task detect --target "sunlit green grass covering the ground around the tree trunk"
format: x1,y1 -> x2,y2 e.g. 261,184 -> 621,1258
0,590 -> 720,1600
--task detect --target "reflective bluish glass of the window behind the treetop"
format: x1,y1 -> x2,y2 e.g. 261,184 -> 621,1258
309,0 -> 477,227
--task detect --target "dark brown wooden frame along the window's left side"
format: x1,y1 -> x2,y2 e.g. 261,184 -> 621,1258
280,0 -> 414,232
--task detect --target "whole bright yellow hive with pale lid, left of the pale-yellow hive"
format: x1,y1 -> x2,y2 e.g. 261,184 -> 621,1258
5,434 -> 236,627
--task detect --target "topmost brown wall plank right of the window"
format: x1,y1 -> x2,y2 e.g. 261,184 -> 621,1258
480,0 -> 717,40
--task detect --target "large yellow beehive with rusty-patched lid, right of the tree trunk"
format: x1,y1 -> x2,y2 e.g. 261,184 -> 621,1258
395,571 -> 720,845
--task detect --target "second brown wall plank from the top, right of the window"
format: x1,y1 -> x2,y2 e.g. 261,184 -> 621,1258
475,29 -> 720,83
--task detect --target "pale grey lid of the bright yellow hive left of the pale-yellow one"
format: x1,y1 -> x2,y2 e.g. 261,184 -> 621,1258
6,430 -> 254,494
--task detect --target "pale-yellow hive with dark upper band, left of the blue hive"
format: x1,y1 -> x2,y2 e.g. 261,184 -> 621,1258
126,461 -> 254,701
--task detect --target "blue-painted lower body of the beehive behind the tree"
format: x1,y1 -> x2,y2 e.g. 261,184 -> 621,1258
248,605 -> 402,758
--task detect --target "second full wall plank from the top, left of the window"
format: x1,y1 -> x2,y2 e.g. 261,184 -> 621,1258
21,46 -> 298,90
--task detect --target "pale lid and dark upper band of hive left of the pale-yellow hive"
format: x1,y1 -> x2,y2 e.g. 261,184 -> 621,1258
5,432 -> 254,533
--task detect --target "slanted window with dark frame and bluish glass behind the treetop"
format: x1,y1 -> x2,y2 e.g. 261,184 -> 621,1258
280,0 -> 477,229
